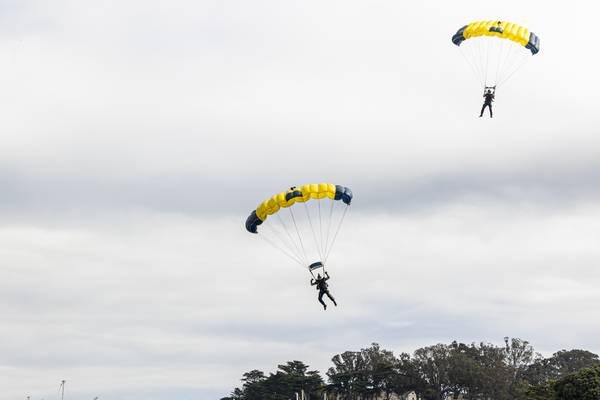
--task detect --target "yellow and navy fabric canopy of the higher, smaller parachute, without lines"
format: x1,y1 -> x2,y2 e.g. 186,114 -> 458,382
452,21 -> 540,55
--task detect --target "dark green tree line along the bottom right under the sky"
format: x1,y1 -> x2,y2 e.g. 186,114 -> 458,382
221,337 -> 600,400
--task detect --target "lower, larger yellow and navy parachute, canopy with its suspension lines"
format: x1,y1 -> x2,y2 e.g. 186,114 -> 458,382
246,183 -> 353,276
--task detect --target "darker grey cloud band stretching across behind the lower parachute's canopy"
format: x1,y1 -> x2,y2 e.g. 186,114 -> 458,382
0,158 -> 600,220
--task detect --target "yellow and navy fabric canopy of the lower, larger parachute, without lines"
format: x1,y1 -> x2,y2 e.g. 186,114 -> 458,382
246,183 -> 352,233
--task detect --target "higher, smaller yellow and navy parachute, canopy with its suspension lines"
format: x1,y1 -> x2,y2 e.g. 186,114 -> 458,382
452,21 -> 540,89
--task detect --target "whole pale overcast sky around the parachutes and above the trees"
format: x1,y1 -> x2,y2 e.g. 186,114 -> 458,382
0,0 -> 600,400
